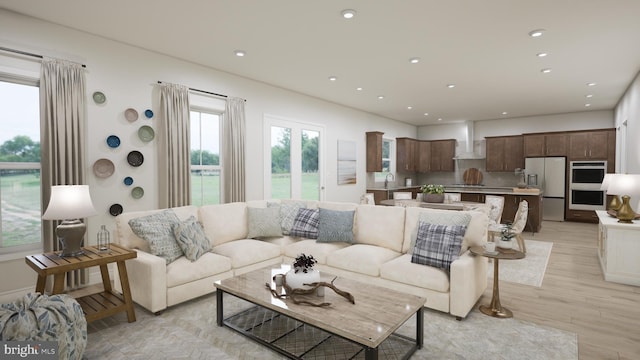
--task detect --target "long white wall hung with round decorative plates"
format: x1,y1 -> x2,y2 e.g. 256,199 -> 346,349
0,9 -> 416,300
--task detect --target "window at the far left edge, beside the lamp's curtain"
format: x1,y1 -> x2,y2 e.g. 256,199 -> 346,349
0,79 -> 42,254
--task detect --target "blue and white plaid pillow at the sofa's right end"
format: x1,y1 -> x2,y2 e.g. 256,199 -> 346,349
411,221 -> 467,271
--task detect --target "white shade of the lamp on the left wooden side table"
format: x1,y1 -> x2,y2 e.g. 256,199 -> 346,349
42,185 -> 98,220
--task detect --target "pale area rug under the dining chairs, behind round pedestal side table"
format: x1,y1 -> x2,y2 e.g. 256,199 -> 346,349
487,239 -> 553,287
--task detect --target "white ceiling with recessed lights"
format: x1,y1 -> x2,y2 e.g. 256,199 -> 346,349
0,0 -> 640,125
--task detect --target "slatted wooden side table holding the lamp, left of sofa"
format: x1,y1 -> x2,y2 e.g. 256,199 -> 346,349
25,244 -> 138,322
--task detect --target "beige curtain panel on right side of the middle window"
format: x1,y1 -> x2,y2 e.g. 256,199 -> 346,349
222,97 -> 246,203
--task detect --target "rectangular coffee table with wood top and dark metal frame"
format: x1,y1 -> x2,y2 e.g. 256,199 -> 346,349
215,268 -> 425,360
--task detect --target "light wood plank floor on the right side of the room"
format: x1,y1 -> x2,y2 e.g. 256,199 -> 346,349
496,221 -> 640,360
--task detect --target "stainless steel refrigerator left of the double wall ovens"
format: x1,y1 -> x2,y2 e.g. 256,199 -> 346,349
524,157 -> 567,221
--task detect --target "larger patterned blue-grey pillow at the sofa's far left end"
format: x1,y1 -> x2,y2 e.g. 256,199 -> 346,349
129,209 -> 183,265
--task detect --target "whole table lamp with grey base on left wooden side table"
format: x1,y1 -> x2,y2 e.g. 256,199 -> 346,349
42,185 -> 97,256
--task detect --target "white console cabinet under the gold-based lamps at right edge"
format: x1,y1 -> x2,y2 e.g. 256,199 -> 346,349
596,210 -> 640,286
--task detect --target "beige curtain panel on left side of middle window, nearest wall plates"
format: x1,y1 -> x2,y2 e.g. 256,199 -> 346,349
158,83 -> 191,208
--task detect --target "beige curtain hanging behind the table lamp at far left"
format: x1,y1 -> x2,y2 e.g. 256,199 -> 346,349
40,58 -> 88,288
